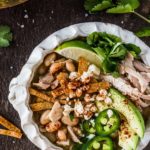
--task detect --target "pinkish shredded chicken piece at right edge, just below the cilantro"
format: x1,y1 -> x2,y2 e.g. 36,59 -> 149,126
133,60 -> 150,73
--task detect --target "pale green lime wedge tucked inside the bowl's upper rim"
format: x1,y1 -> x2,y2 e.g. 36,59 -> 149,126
56,41 -> 102,67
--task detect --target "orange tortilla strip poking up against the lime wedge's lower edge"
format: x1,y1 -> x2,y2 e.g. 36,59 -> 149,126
78,57 -> 89,75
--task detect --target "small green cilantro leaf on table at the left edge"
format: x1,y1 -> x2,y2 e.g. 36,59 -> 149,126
0,25 -> 12,47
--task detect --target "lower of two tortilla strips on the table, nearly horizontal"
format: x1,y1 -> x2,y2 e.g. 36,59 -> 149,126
0,129 -> 22,139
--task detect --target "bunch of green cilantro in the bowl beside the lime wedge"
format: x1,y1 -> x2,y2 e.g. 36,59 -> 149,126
86,32 -> 141,76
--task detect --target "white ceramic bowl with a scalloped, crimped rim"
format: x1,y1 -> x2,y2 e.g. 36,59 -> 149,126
9,22 -> 150,150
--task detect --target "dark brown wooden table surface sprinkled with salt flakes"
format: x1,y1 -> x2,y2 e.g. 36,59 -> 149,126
0,0 -> 150,150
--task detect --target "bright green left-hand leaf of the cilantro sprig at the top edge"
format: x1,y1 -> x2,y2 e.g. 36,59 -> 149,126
91,0 -> 112,12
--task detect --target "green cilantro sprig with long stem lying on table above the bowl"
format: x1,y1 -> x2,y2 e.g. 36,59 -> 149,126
84,0 -> 150,23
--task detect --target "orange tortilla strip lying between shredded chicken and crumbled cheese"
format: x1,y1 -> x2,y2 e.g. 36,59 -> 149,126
87,81 -> 110,93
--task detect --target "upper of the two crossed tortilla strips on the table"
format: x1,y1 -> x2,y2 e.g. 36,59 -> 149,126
0,115 -> 21,133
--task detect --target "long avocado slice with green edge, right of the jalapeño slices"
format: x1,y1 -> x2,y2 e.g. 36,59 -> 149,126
109,88 -> 145,138
